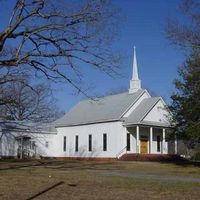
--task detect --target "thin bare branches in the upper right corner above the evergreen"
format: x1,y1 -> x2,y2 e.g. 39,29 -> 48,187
165,0 -> 200,50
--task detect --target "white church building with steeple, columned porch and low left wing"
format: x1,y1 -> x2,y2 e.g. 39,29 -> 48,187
0,48 -> 176,159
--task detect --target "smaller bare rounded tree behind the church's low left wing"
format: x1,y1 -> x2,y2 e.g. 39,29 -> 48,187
0,79 -> 61,122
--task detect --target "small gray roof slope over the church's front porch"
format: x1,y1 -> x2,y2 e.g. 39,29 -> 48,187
124,97 -> 160,125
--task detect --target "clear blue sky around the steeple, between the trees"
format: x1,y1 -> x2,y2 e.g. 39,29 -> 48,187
0,0 -> 184,111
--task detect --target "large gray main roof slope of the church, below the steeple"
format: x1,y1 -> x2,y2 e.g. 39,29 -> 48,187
55,90 -> 144,127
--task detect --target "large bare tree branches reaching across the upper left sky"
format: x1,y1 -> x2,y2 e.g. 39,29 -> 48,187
0,0 -> 119,95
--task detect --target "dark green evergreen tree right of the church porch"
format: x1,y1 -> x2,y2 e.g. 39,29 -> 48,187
171,49 -> 200,148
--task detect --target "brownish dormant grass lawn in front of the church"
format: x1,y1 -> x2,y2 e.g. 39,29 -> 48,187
0,160 -> 200,200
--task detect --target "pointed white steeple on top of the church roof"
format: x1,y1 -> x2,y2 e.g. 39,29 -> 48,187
129,46 -> 141,94
